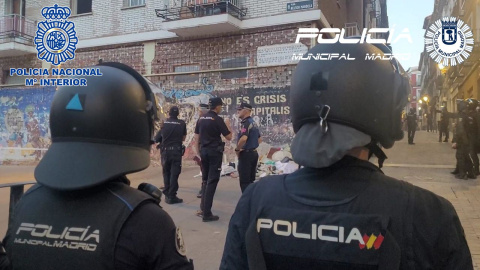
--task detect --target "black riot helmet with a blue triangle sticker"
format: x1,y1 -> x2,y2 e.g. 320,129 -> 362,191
35,63 -> 157,190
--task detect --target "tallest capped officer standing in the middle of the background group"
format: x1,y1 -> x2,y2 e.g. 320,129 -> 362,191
195,97 -> 232,222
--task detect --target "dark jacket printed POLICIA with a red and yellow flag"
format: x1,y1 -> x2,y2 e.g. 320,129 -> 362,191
220,156 -> 473,270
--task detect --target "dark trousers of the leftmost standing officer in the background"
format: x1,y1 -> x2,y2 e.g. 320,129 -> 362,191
162,150 -> 182,198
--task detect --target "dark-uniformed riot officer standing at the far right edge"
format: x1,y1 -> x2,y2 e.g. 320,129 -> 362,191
452,99 -> 475,180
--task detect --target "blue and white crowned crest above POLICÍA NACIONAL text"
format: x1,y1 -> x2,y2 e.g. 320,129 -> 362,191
35,4 -> 78,66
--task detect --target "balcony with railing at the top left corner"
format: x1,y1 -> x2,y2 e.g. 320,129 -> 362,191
0,14 -> 37,57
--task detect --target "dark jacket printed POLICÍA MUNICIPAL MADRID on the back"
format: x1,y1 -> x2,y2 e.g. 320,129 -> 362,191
3,181 -> 193,270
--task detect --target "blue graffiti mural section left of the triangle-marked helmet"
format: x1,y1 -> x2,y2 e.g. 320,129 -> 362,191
0,87 -> 55,164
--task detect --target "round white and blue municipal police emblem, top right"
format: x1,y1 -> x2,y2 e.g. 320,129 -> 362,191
425,17 -> 474,66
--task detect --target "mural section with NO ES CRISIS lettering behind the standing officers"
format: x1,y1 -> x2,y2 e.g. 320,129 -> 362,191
158,81 -> 293,159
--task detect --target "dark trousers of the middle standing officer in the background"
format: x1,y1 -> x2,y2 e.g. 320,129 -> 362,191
200,148 -> 223,217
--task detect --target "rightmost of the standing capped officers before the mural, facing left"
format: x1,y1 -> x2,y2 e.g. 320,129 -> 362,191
235,102 -> 261,193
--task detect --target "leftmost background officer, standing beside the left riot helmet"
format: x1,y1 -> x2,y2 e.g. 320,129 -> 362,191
155,106 -> 187,204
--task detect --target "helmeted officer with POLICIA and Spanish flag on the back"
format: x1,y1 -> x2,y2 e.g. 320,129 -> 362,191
220,43 -> 473,270
